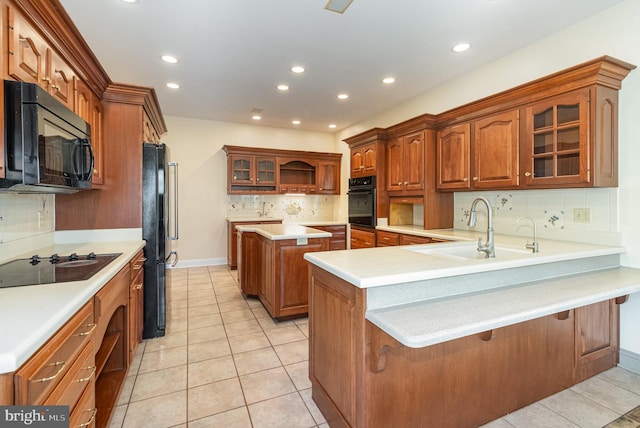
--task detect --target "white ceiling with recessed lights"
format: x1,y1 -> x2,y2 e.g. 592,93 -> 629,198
61,0 -> 622,132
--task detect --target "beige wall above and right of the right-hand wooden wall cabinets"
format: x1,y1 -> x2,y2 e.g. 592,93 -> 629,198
336,0 -> 640,354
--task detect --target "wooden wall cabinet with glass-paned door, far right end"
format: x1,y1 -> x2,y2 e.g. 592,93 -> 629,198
522,86 -> 618,187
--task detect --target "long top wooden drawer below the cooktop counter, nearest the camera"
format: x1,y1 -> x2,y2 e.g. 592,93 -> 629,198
15,301 -> 96,405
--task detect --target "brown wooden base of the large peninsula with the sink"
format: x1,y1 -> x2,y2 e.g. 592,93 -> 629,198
309,265 -> 624,428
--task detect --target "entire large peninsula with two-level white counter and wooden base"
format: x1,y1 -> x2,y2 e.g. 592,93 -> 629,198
305,234 -> 640,427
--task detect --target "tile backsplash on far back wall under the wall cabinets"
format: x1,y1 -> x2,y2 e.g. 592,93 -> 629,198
227,195 -> 339,221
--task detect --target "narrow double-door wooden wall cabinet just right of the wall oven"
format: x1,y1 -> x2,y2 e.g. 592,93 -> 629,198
387,132 -> 425,194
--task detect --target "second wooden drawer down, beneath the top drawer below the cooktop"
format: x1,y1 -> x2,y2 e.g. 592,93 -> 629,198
44,343 -> 96,412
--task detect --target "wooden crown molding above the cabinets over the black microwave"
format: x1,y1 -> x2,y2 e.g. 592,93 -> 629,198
6,0 -> 111,95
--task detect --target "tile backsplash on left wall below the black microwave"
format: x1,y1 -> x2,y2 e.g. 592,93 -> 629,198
0,193 -> 55,244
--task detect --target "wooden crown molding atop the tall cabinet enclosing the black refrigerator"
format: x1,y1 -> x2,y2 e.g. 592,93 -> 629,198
103,83 -> 167,136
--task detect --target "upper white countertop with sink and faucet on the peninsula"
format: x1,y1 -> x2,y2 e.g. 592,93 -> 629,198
304,230 -> 624,288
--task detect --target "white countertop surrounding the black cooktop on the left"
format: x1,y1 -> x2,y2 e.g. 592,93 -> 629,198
0,240 -> 145,374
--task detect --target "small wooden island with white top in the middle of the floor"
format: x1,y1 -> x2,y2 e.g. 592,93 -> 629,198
236,223 -> 332,319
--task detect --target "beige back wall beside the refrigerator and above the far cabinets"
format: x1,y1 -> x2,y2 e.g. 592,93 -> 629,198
162,116 -> 336,266
